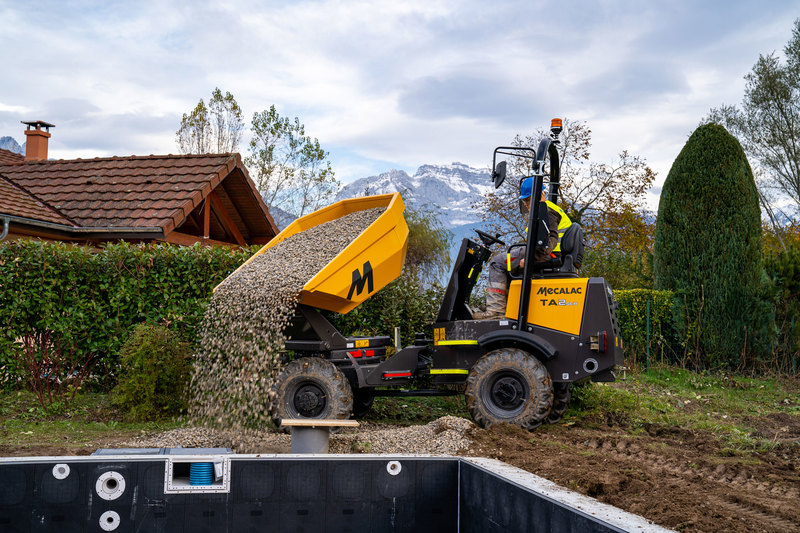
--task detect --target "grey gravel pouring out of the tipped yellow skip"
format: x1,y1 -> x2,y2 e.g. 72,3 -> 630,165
190,208 -> 384,434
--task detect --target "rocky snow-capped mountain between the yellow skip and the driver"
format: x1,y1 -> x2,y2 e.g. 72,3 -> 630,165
336,163 -> 492,229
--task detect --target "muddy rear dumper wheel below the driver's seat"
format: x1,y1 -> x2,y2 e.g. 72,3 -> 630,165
465,348 -> 553,429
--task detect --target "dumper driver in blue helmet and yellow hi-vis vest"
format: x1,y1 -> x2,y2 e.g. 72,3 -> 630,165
483,177 -> 572,319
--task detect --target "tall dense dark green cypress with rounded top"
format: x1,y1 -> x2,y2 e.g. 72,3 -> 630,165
653,124 -> 767,367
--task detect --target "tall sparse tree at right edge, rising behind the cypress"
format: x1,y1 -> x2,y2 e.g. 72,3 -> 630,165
703,19 -> 800,248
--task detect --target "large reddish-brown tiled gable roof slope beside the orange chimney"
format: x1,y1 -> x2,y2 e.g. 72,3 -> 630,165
0,152 -> 275,236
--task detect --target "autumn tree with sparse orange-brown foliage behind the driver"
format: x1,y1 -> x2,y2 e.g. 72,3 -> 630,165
476,119 -> 655,288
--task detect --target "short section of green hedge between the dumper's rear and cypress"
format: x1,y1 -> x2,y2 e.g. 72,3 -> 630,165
614,289 -> 683,365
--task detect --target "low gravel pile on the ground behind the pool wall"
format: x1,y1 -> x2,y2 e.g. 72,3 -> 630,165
120,416 -> 476,455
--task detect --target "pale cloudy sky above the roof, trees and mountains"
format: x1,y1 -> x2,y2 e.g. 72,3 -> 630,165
0,0 -> 800,207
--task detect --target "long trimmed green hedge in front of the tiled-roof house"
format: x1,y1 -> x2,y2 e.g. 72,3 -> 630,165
0,240 -> 253,384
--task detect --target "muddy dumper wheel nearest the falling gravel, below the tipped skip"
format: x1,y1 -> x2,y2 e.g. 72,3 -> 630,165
270,357 -> 353,433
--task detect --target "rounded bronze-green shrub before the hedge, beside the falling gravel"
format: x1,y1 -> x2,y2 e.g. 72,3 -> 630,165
112,323 -> 191,421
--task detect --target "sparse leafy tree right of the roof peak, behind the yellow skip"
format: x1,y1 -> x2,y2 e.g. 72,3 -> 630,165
246,105 -> 340,217
